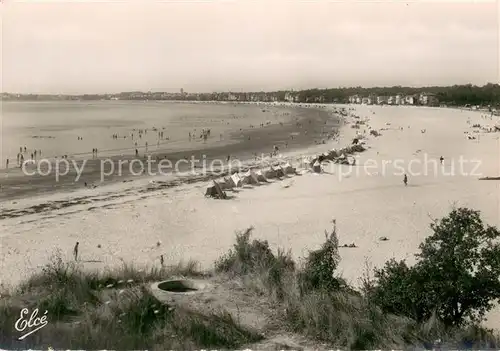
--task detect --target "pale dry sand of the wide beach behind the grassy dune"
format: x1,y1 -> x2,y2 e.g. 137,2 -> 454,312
0,105 -> 500,329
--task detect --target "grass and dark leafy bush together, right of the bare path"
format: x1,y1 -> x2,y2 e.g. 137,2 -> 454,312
216,208 -> 500,349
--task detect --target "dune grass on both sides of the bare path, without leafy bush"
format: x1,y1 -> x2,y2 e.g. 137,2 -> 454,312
0,223 -> 500,350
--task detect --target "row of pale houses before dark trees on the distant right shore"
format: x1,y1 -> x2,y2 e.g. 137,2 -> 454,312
349,93 -> 439,106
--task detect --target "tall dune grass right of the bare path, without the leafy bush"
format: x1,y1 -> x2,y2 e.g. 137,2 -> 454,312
215,227 -> 500,350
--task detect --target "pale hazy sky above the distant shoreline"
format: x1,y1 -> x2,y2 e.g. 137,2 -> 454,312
0,0 -> 500,94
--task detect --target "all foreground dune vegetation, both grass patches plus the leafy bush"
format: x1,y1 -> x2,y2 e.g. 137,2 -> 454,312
0,208 -> 500,350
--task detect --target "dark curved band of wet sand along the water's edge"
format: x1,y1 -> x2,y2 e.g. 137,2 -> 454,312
0,107 -> 340,201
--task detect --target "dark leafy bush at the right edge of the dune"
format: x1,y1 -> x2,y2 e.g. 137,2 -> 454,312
368,208 -> 500,327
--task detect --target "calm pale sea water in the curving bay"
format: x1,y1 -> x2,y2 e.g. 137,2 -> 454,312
0,101 -> 289,168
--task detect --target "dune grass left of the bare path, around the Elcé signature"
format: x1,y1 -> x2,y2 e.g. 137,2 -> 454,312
0,256 -> 261,350
